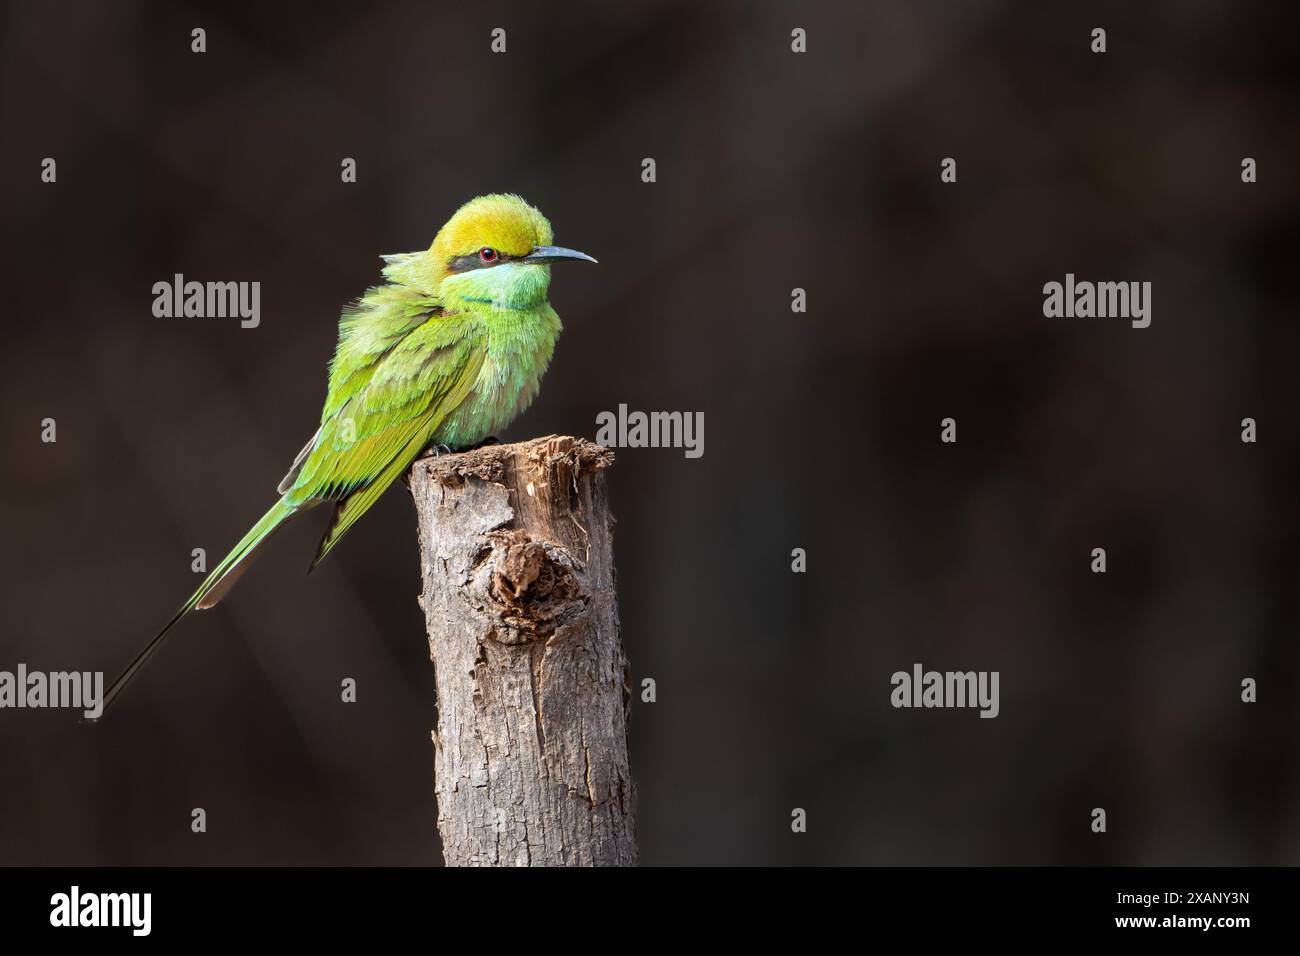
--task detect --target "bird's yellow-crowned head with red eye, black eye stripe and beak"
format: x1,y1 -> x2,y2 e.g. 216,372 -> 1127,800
385,195 -> 595,310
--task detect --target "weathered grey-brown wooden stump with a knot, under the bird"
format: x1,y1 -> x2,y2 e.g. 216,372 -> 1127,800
410,436 -> 637,866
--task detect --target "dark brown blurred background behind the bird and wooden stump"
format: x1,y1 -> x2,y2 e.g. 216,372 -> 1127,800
0,0 -> 1300,864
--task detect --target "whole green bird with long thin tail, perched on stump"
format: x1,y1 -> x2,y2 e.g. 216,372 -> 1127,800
96,194 -> 597,719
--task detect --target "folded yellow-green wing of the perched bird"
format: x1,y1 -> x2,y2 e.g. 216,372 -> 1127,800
281,303 -> 486,567
